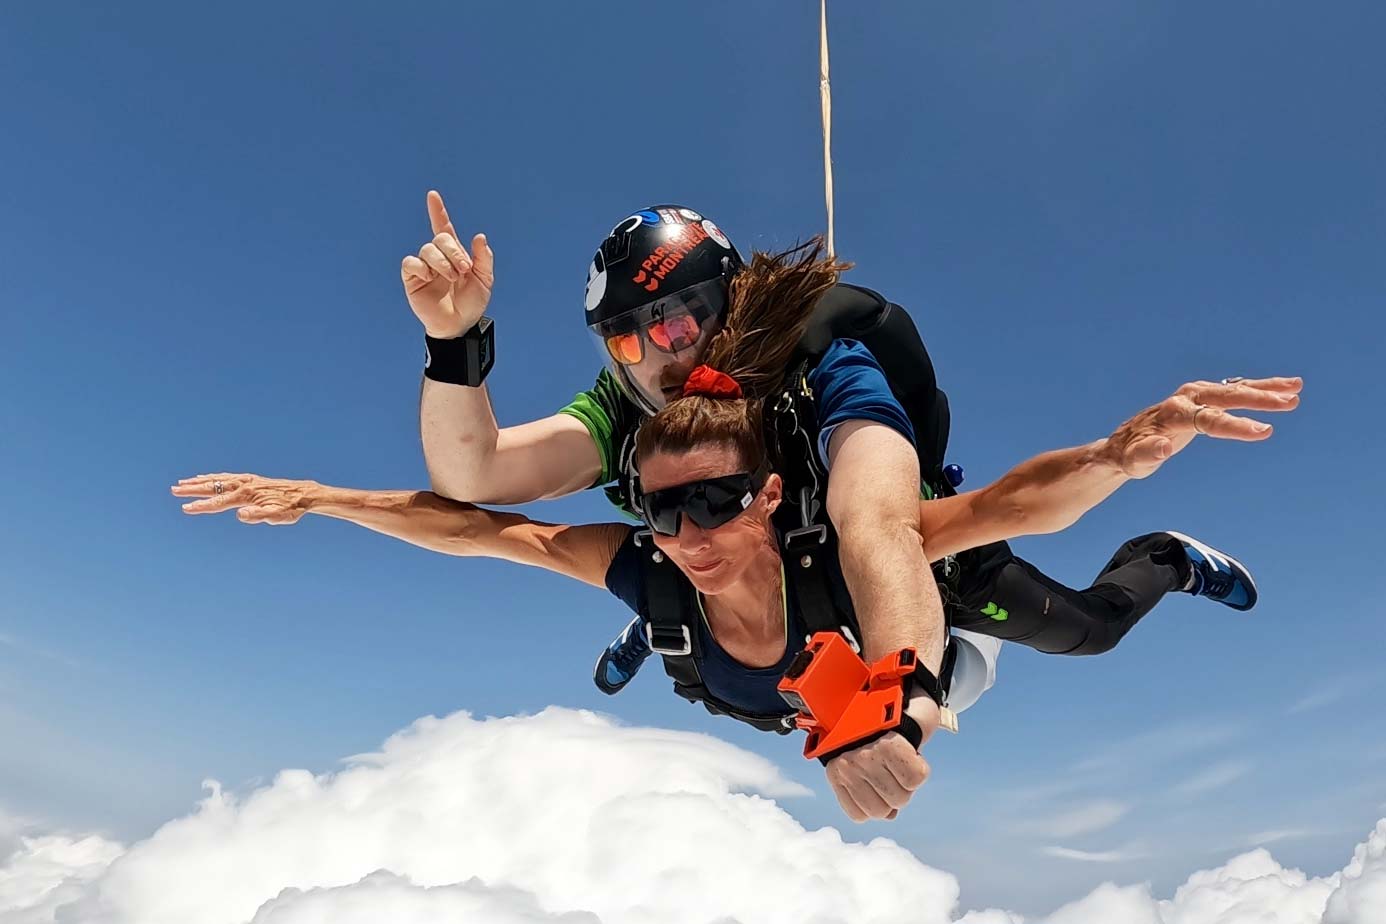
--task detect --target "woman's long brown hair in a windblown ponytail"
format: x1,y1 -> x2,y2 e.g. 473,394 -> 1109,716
636,237 -> 852,467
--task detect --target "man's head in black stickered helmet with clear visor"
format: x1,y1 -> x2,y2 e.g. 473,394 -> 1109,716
586,205 -> 744,414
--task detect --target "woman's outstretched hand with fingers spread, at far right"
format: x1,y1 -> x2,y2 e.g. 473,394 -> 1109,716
1103,377 -> 1304,478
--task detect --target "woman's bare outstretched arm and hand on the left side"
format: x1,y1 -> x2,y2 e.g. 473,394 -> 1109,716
172,472 -> 631,587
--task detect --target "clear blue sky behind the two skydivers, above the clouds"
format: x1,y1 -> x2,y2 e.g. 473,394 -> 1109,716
0,3 -> 1386,910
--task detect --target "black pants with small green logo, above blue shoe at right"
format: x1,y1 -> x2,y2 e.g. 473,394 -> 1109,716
941,532 -> 1191,654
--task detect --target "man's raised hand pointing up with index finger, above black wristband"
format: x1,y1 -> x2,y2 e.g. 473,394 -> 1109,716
399,190 -> 496,339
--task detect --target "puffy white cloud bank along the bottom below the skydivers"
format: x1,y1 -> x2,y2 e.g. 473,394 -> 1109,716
0,708 -> 1386,924
